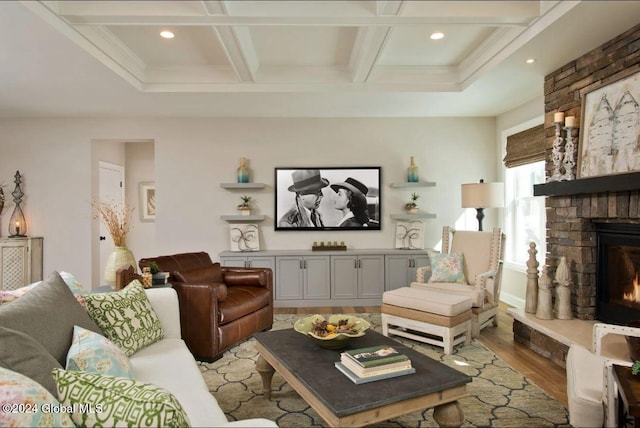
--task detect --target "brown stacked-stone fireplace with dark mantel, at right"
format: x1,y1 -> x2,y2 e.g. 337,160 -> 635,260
507,24 -> 640,366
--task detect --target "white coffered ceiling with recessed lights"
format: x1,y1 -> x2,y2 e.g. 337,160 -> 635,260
0,0 -> 640,116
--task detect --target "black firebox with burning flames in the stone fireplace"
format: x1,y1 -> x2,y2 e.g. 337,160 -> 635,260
596,223 -> 640,325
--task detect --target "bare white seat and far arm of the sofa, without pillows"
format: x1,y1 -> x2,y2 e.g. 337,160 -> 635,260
138,288 -> 277,427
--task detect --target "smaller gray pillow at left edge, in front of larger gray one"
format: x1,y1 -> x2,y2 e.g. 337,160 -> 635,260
0,327 -> 63,397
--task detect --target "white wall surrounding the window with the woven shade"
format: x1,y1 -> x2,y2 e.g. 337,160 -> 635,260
496,97 -> 544,308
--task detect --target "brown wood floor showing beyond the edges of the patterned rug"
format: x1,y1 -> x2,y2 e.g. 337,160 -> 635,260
274,303 -> 567,407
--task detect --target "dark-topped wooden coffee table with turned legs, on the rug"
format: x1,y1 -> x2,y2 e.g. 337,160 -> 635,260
254,329 -> 471,427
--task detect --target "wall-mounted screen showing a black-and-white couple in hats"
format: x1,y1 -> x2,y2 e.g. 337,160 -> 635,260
275,167 -> 381,231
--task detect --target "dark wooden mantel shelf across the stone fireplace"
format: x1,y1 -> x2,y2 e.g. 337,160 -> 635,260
533,172 -> 640,196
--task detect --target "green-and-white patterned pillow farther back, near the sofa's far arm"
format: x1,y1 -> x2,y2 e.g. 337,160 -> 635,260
86,280 -> 164,357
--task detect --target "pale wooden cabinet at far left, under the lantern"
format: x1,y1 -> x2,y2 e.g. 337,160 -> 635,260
0,238 -> 43,290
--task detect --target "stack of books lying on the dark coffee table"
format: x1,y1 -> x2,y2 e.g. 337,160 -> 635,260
335,345 -> 416,384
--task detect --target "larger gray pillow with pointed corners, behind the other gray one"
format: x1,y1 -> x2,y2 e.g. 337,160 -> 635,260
0,272 -> 102,367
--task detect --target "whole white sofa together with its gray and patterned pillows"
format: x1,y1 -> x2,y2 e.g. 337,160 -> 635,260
0,272 -> 277,427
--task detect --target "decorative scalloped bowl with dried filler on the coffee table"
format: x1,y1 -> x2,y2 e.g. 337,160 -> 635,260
293,314 -> 371,349
